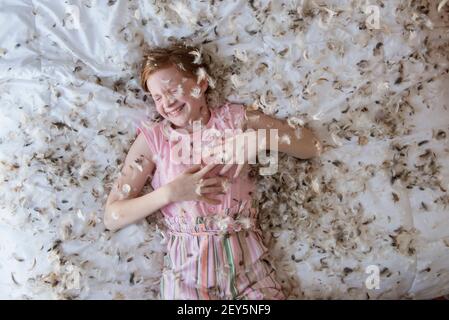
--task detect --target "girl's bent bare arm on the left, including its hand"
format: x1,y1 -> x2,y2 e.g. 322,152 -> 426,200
104,134 -> 226,231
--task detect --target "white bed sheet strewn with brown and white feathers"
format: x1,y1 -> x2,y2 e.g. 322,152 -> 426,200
0,0 -> 449,299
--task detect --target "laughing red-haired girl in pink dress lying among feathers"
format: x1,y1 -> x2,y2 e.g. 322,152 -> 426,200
104,44 -> 321,299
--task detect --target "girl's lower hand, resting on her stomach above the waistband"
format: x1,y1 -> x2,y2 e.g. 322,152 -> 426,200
167,164 -> 228,205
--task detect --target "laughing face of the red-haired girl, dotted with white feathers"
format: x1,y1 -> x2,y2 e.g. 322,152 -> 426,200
146,65 -> 208,128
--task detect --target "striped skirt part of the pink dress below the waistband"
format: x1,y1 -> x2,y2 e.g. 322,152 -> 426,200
161,230 -> 285,300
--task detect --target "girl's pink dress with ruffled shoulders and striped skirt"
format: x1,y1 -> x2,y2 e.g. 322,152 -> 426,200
137,102 -> 285,299
